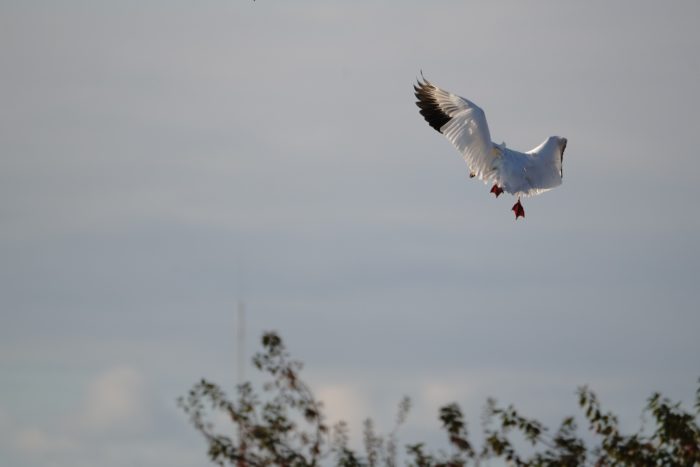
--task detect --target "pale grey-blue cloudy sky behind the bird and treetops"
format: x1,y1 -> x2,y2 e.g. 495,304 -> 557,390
0,0 -> 700,467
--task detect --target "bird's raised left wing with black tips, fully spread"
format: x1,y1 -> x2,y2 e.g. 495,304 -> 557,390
413,78 -> 501,182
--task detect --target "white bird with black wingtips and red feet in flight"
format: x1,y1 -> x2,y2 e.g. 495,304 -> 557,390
413,73 -> 566,220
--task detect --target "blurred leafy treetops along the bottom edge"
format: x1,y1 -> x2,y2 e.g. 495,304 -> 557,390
178,332 -> 700,467
